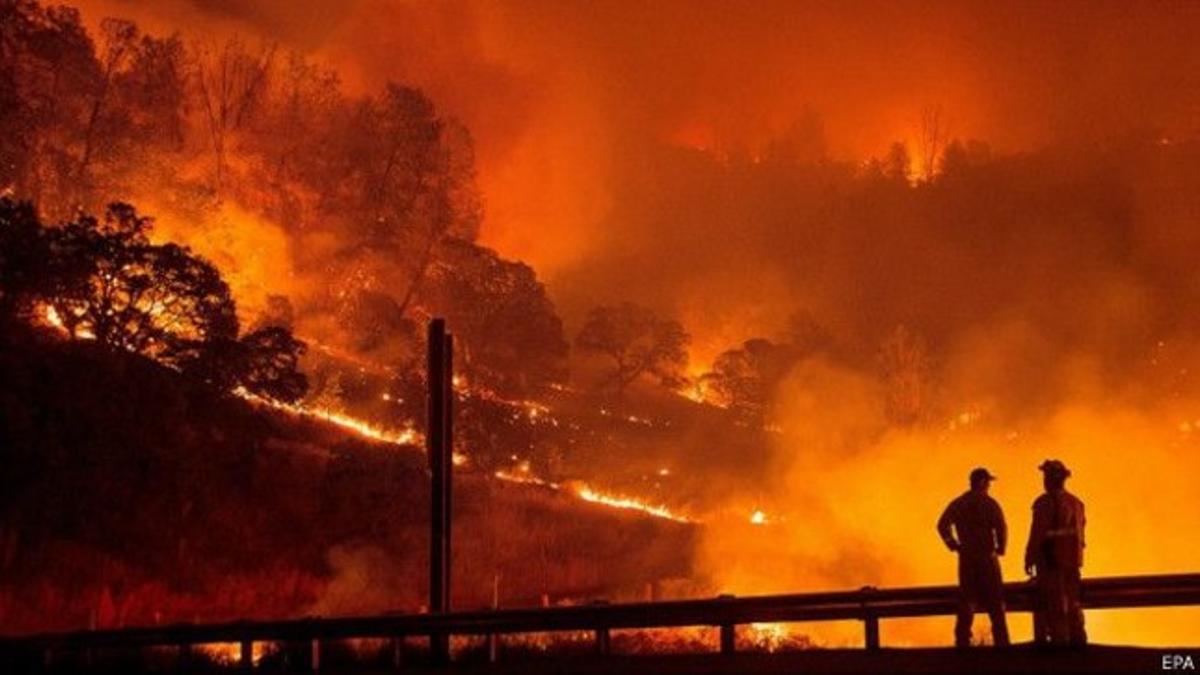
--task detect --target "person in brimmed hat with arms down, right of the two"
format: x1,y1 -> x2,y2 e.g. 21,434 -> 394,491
1025,460 -> 1087,645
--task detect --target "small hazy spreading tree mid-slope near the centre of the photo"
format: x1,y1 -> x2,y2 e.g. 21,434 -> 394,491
575,303 -> 689,393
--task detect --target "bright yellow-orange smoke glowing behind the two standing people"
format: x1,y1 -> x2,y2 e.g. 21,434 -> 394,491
703,355 -> 1200,645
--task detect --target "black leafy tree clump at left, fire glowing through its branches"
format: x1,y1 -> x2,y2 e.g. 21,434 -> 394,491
0,198 -> 307,401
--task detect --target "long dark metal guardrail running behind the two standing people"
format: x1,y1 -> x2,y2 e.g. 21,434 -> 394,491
0,574 -> 1200,669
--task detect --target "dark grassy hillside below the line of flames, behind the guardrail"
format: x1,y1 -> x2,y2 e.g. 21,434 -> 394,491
0,335 -> 694,633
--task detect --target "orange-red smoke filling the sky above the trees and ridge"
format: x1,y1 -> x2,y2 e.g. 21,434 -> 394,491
84,0 -> 1200,309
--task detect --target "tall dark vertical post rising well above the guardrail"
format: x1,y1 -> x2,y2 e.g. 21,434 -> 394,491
426,318 -> 454,665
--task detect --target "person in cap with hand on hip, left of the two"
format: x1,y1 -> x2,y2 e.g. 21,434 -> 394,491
937,468 -> 1008,647
